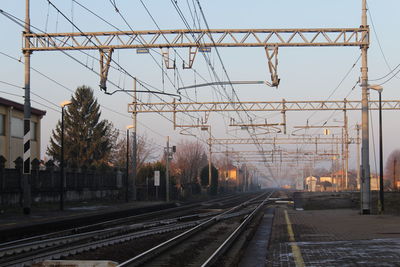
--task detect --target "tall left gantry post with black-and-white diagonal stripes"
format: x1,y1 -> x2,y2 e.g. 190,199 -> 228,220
23,0 -> 32,215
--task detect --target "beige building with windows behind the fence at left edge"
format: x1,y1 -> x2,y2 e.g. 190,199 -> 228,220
0,97 -> 46,168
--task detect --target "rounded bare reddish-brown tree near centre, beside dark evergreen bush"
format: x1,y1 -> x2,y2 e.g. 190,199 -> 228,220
174,141 -> 205,191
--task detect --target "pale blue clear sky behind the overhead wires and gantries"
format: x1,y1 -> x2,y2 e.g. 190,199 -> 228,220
0,0 -> 400,184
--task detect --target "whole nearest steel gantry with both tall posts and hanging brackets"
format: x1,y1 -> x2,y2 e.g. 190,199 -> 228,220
22,0 -> 370,211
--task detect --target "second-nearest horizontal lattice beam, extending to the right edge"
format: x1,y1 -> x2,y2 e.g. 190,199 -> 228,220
128,100 -> 400,113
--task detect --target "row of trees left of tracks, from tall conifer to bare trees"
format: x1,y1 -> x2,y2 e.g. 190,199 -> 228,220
46,86 -> 222,196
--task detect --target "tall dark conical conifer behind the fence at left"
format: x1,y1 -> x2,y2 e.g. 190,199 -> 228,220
46,86 -> 117,168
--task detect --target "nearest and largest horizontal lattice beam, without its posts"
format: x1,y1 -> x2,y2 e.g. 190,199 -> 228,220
23,28 -> 369,51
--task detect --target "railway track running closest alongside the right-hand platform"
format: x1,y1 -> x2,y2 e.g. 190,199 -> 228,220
118,193 -> 272,267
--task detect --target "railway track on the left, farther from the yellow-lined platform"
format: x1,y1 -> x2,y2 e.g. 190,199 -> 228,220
0,193 -> 268,266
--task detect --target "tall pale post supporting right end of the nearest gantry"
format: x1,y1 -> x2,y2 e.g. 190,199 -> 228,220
361,0 -> 371,214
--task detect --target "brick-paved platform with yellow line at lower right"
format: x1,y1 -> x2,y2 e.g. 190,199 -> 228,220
267,207 -> 400,267
